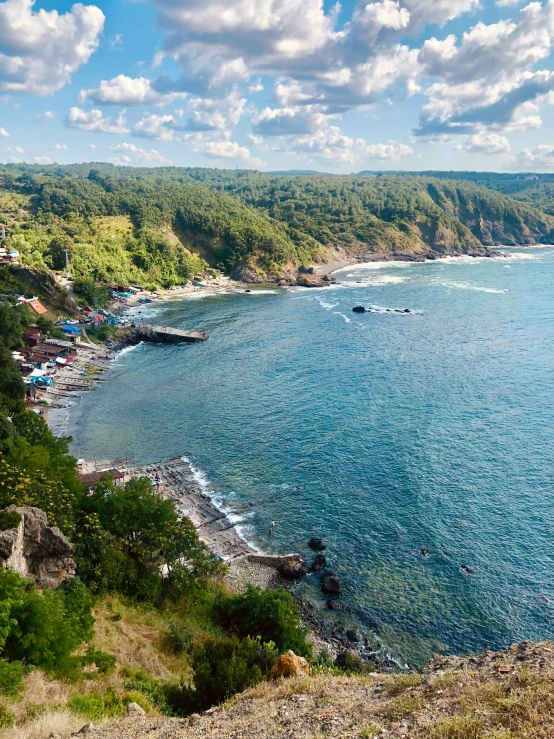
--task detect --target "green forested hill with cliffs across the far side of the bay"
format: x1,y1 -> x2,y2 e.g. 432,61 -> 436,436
0,164 -> 554,286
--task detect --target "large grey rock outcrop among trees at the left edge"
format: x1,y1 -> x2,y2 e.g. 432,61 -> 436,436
0,506 -> 75,588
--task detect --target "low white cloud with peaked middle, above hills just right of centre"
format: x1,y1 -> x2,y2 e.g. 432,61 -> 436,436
291,126 -> 413,163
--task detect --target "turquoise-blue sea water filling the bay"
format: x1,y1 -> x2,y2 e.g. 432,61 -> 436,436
64,248 -> 554,662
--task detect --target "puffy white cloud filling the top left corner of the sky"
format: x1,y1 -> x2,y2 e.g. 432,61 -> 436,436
0,0 -> 104,95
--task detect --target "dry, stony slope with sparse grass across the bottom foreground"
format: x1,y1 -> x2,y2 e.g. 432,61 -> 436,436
72,642 -> 554,739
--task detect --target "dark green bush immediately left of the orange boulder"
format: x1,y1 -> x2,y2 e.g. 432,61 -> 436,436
164,637 -> 279,715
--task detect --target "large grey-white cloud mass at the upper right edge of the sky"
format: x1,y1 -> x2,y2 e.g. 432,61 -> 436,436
416,0 -> 554,136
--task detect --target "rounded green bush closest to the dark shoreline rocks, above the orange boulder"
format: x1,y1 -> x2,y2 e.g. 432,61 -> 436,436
216,585 -> 312,657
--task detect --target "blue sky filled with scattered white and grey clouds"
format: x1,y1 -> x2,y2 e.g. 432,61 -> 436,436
0,0 -> 554,173
